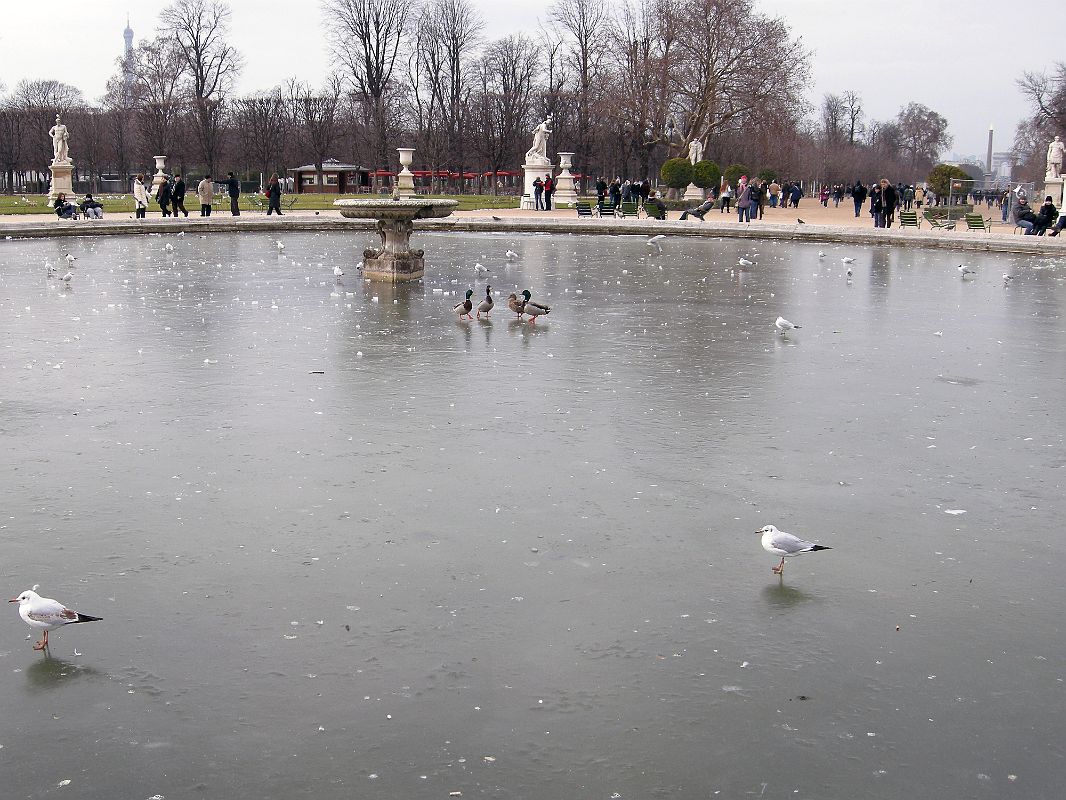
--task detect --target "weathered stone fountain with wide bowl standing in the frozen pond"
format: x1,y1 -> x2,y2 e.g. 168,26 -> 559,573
334,197 -> 458,284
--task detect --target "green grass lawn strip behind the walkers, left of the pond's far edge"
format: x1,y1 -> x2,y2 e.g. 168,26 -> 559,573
0,194 -> 519,217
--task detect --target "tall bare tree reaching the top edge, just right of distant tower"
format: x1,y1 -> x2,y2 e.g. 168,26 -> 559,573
159,0 -> 241,174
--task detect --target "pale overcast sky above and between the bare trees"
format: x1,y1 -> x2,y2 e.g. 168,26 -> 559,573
0,0 -> 1066,160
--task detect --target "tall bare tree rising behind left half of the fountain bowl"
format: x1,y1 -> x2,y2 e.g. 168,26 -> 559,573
322,0 -> 411,167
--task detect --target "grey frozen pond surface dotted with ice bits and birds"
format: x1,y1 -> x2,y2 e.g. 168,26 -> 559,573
0,233 -> 1066,800
